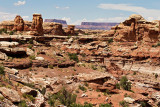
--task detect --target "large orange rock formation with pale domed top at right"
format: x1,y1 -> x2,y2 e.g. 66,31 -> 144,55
112,15 -> 159,42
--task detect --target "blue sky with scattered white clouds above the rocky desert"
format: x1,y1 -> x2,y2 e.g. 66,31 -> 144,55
0,0 -> 160,24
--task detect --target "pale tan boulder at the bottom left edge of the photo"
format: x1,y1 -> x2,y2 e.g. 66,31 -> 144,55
0,87 -> 21,102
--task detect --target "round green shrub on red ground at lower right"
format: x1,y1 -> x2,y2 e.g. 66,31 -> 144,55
120,76 -> 131,91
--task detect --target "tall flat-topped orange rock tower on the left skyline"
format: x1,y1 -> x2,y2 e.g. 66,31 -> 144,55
31,14 -> 44,36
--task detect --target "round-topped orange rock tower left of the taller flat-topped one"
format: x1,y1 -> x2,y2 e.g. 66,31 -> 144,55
12,15 -> 24,31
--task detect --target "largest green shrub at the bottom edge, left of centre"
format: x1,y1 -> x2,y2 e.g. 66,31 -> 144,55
48,88 -> 77,107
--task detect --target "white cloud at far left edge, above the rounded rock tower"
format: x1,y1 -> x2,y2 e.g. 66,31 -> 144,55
0,12 -> 16,21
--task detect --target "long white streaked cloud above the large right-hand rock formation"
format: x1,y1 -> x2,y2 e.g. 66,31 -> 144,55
98,4 -> 160,20
